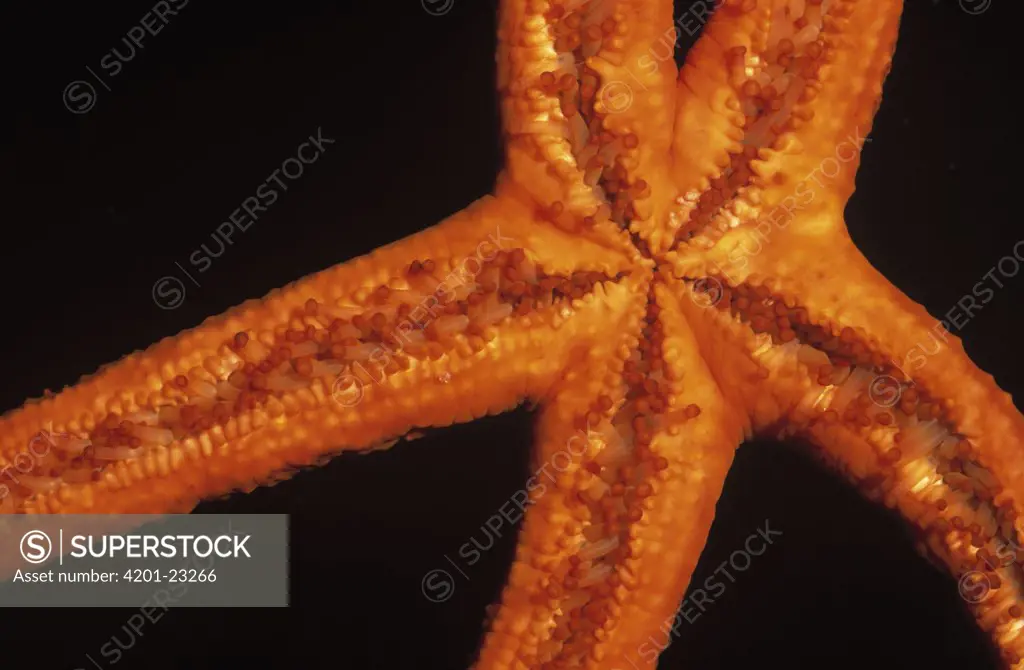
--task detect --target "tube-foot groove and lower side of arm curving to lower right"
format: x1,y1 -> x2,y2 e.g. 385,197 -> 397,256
688,280 -> 1024,664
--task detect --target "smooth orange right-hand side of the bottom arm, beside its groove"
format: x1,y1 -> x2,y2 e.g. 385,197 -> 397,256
595,284 -> 746,668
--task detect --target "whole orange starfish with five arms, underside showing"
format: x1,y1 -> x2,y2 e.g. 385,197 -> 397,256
0,0 -> 1024,670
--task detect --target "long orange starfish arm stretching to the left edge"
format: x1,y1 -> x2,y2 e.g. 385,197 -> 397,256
0,197 -> 626,513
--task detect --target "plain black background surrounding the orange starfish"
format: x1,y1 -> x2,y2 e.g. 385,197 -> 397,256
0,0 -> 1024,669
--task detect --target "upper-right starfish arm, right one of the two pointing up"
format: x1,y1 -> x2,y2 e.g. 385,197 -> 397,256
670,0 -> 902,254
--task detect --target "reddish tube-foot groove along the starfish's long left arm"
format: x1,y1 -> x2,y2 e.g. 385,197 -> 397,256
0,238 -> 626,513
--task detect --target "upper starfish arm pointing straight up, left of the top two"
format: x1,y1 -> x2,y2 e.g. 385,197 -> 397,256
498,0 -> 676,260
